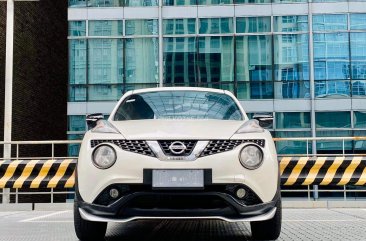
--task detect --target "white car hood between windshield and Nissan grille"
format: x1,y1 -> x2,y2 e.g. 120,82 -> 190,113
111,120 -> 244,140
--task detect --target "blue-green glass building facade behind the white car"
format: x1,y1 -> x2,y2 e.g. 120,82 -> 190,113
68,0 -> 366,155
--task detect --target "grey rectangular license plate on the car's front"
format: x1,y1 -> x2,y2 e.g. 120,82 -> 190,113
152,170 -> 204,188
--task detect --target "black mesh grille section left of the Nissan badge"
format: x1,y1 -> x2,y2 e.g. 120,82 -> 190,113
90,140 -> 155,157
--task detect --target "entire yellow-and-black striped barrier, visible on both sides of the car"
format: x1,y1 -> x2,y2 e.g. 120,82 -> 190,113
0,157 -> 366,189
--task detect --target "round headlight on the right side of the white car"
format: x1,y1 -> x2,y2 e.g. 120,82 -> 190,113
239,145 -> 263,170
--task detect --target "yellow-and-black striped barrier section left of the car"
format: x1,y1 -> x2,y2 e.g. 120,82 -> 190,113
0,159 -> 76,188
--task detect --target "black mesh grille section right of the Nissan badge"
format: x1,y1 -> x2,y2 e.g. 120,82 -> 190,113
200,139 -> 265,157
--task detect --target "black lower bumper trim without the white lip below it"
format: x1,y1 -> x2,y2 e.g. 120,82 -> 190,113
78,192 -> 279,219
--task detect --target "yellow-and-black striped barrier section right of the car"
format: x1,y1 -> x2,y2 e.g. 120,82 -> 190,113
280,156 -> 366,186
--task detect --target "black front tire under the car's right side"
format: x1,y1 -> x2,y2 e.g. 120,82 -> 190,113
250,200 -> 282,240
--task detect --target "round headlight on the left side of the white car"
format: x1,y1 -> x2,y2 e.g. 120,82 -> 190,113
93,145 -> 117,169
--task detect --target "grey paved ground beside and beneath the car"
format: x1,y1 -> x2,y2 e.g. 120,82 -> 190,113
0,209 -> 366,241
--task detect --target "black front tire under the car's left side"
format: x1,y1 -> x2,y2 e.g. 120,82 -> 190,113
74,201 -> 107,241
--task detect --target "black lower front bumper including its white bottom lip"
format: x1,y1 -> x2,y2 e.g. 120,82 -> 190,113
76,184 -> 281,222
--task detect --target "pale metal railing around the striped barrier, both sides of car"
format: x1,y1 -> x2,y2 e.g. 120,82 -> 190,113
0,137 -> 366,203
